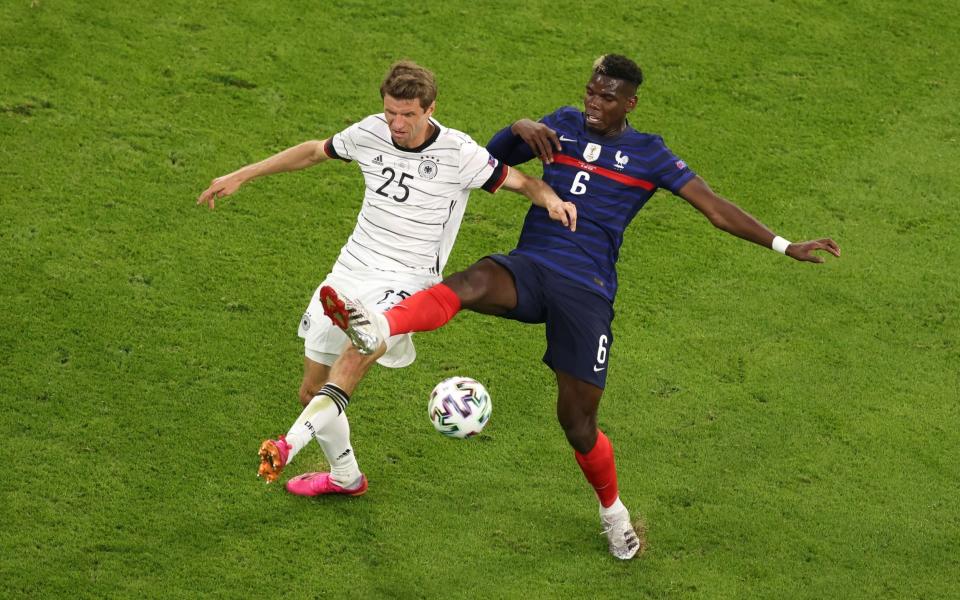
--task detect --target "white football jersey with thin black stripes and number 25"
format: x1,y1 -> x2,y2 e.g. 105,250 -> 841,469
324,114 -> 507,277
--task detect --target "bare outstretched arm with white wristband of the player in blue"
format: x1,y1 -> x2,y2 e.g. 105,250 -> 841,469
678,176 -> 840,263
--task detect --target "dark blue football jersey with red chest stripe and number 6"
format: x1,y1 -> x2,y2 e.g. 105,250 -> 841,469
487,106 -> 695,302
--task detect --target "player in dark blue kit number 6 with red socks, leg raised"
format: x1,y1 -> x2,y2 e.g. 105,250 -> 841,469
321,54 -> 840,559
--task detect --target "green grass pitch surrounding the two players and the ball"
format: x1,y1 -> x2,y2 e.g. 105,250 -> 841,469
0,0 -> 960,598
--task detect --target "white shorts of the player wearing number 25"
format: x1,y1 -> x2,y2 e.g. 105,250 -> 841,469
297,272 -> 439,368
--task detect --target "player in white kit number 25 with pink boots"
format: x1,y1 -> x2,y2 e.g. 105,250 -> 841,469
197,61 -> 576,496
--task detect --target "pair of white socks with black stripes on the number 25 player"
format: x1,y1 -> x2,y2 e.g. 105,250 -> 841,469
286,383 -> 361,487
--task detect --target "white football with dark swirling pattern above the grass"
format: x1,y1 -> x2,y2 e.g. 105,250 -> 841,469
427,377 -> 493,438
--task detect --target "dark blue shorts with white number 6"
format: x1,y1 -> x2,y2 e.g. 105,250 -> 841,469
487,254 -> 613,388
